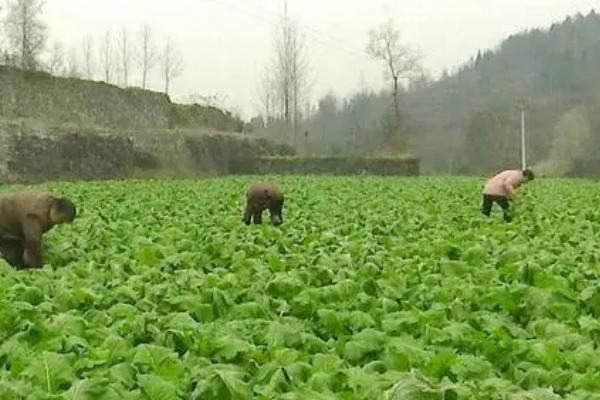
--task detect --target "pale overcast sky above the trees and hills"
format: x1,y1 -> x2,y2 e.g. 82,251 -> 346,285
44,0 -> 600,117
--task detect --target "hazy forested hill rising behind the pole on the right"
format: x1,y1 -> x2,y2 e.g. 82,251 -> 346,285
405,11 -> 600,173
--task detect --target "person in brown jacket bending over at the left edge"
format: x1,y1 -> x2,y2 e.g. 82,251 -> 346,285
0,191 -> 76,269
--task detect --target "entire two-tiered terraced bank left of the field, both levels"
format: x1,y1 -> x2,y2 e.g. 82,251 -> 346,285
0,67 -> 294,183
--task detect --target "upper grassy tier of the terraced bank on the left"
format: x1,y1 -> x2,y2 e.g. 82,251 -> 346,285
0,66 -> 244,133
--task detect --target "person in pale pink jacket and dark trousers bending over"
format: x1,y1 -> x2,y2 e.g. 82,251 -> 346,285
482,169 -> 534,222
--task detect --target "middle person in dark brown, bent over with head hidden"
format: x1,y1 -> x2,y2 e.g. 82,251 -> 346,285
244,182 -> 283,226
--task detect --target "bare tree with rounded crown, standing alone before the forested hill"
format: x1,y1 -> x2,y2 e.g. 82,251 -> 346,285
367,19 -> 421,144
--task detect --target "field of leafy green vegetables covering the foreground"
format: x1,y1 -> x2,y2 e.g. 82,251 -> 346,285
0,177 -> 600,400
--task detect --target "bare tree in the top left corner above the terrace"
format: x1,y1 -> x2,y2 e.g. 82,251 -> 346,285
4,0 -> 47,70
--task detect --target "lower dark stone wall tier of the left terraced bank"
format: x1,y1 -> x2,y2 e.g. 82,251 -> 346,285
0,125 -> 293,182
